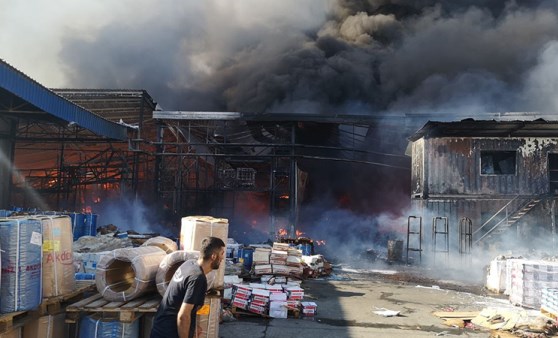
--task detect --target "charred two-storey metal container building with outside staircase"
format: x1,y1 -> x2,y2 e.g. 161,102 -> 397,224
410,119 -> 558,252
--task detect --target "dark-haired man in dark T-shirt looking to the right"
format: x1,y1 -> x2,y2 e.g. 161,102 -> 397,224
151,237 -> 225,338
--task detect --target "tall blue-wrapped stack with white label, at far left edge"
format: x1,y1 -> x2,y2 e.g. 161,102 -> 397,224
0,218 -> 43,313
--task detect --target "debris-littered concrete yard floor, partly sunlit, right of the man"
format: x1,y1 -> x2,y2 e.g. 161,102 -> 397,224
219,271 -> 532,338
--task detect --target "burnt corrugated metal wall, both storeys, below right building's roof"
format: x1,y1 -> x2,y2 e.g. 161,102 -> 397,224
411,137 -> 558,248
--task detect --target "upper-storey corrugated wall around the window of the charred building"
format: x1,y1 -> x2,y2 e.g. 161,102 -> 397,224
412,138 -> 558,198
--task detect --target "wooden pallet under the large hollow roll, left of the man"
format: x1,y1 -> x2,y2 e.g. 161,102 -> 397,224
66,293 -> 161,324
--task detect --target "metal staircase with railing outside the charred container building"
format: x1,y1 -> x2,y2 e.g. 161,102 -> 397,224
473,196 -> 542,244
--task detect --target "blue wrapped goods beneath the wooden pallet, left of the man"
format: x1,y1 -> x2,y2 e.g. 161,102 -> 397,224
79,315 -> 140,338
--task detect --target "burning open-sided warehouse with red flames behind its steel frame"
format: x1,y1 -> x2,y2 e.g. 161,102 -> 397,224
0,58 -> 412,246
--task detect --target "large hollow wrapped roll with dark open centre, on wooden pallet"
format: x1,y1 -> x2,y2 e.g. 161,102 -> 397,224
95,246 -> 166,301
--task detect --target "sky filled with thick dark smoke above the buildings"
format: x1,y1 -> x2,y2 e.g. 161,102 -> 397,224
0,0 -> 558,115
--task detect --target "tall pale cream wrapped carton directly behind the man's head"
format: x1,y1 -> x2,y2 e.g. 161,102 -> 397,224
180,216 -> 229,289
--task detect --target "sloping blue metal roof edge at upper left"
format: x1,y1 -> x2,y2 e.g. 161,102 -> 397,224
0,59 -> 128,140
